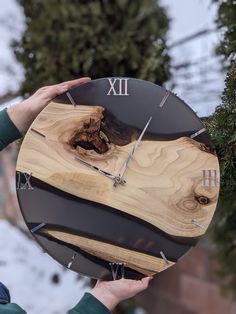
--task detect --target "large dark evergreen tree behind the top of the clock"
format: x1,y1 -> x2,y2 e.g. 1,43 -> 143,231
13,0 -> 169,95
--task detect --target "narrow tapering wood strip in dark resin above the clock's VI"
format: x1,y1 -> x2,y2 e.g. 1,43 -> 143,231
41,228 -> 175,276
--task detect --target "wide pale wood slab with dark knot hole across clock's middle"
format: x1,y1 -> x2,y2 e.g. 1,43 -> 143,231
17,102 -> 219,237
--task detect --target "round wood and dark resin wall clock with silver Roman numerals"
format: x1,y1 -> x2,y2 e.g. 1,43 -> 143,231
16,77 -> 219,280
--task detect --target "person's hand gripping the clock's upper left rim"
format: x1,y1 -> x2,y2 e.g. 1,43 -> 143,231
7,77 -> 91,134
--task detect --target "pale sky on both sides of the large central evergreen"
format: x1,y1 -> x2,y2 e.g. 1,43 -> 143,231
0,0 -> 224,115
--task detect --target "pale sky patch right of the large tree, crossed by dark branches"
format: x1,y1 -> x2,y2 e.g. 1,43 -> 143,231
161,0 -> 225,116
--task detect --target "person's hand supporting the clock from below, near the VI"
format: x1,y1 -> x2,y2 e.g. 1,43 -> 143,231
91,277 -> 153,311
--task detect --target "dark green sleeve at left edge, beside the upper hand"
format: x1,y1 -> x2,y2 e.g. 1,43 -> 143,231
0,109 -> 22,151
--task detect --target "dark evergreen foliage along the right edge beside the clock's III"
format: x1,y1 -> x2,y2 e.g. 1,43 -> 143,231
209,0 -> 236,297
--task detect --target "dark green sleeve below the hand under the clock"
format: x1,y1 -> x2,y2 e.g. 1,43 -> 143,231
68,292 -> 111,314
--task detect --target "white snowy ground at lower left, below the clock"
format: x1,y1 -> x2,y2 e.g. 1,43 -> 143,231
0,220 -> 90,314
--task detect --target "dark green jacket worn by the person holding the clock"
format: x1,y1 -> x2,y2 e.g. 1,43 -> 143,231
0,109 -> 111,314
